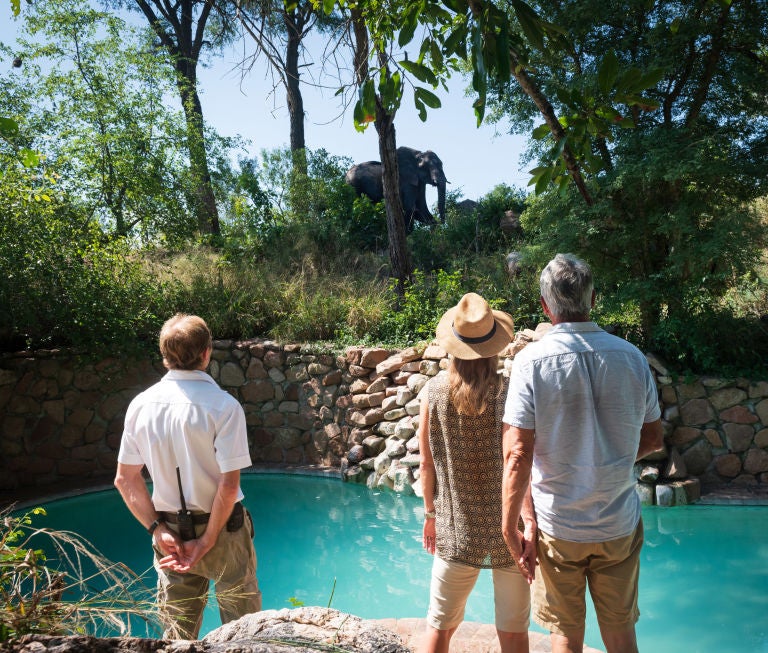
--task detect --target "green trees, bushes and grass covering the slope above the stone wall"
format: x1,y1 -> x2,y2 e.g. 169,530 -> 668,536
0,0 -> 768,375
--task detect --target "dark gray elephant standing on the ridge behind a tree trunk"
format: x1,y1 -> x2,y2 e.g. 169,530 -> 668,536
345,147 -> 449,233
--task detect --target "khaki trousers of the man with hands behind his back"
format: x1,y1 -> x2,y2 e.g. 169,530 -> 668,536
154,510 -> 261,639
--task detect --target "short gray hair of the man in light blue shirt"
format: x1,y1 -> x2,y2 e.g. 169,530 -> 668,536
539,254 -> 594,322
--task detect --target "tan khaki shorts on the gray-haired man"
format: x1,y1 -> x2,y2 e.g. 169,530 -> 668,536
533,519 -> 643,637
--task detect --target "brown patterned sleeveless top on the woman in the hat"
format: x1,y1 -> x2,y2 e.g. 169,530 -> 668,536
427,373 -> 515,569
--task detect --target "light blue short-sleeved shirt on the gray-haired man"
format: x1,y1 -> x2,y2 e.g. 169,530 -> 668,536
504,322 -> 661,542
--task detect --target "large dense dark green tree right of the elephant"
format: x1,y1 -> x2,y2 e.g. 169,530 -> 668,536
492,0 -> 768,342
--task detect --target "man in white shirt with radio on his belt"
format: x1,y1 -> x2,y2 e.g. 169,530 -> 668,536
115,315 -> 261,639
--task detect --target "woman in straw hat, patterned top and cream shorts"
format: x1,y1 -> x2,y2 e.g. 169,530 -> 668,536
419,293 -> 536,653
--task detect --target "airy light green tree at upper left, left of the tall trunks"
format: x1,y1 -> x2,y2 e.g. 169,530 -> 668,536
0,2 -> 195,240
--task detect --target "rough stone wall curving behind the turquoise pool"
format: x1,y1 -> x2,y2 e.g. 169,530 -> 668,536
0,332 -> 768,505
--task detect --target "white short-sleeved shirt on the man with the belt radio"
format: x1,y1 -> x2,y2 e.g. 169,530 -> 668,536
117,370 -> 251,512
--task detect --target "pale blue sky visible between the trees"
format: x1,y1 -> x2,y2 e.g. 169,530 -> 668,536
0,0 -> 532,204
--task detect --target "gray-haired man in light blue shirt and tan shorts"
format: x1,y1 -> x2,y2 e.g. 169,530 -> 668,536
502,254 -> 663,653
